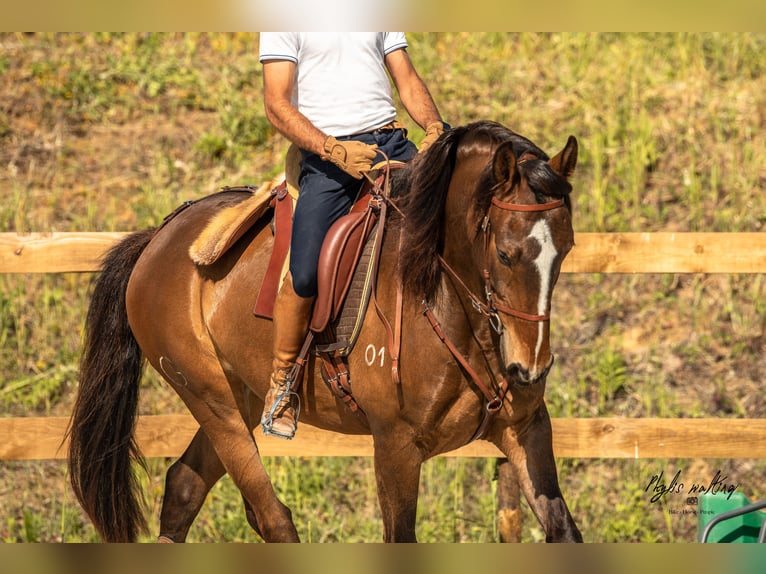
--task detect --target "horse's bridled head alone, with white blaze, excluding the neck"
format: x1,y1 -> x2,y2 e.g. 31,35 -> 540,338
475,136 -> 577,384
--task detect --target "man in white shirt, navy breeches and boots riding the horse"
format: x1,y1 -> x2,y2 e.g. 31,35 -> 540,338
260,32 -> 448,439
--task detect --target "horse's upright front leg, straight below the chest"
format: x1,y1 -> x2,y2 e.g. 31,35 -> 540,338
375,437 -> 422,542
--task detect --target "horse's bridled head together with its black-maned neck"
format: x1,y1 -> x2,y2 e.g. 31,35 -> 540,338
400,122 -> 577,390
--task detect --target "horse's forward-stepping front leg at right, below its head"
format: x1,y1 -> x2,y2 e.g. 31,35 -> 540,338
498,404 -> 582,542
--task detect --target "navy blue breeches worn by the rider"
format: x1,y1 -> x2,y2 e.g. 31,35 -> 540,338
290,129 -> 417,297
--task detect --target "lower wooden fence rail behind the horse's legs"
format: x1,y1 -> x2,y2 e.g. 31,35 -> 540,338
0,415 -> 766,460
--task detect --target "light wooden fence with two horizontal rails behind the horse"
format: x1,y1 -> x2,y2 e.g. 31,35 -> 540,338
0,232 -> 766,460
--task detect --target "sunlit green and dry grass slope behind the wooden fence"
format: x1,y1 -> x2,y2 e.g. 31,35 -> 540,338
0,33 -> 766,542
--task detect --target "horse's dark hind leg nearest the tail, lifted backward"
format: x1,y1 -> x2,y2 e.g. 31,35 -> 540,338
160,430 -> 226,542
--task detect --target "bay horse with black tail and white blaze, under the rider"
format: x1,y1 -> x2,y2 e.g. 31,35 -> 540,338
68,121 -> 582,542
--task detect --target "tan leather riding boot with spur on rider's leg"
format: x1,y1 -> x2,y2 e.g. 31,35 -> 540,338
261,273 -> 314,439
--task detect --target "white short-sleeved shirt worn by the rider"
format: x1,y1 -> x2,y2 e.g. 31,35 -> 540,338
260,32 -> 407,137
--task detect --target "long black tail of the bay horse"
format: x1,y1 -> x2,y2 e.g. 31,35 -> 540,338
68,229 -> 155,542
